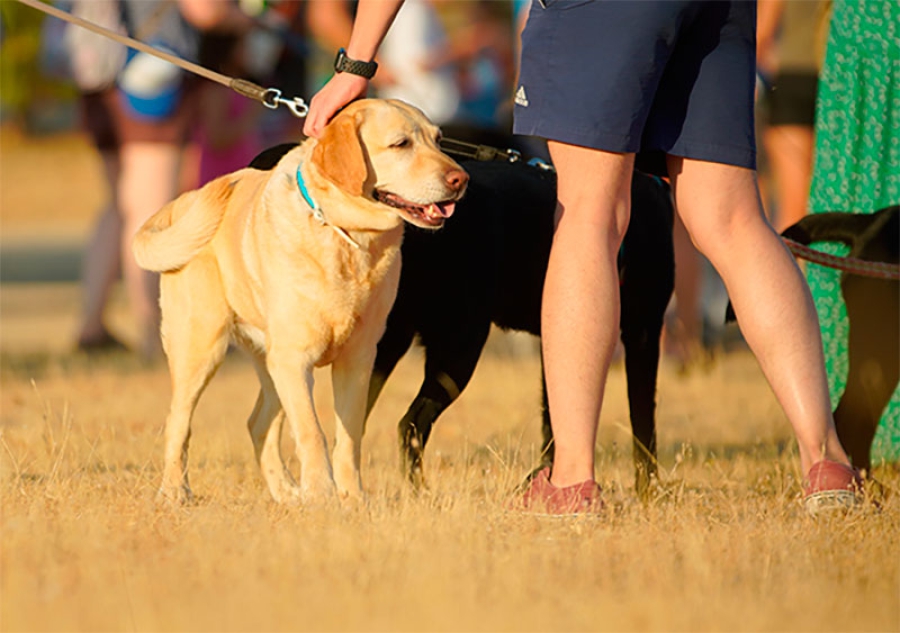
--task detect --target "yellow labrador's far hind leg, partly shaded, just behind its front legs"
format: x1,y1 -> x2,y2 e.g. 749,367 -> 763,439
247,357 -> 300,503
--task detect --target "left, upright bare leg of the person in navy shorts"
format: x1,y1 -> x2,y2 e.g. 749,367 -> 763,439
541,141 -> 634,487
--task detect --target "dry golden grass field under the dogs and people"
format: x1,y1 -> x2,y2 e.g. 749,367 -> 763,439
0,126 -> 900,631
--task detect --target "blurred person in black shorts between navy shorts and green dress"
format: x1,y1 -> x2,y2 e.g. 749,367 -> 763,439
756,0 -> 824,231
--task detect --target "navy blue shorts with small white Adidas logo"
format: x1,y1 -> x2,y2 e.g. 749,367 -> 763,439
514,0 -> 756,173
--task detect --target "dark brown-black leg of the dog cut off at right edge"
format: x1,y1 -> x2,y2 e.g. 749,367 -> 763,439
834,278 -> 900,471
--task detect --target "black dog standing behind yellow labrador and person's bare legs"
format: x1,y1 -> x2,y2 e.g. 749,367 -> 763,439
250,144 -> 675,494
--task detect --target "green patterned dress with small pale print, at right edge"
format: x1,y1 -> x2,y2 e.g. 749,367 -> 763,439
807,0 -> 900,465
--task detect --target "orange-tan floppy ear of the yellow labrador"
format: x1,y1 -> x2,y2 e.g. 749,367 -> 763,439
312,115 -> 368,196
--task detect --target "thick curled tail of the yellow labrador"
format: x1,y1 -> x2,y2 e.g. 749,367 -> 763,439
131,176 -> 234,272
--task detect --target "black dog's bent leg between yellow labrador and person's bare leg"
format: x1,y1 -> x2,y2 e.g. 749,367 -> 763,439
397,324 -> 489,488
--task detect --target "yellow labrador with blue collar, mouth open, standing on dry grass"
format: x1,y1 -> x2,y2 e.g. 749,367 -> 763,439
133,99 -> 468,503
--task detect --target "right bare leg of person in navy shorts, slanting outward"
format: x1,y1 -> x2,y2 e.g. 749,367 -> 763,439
669,156 -> 849,473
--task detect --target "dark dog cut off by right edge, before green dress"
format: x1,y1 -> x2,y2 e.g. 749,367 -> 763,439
782,206 -> 900,470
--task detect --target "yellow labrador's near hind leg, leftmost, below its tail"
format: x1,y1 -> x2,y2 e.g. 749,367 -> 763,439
159,262 -> 228,503
